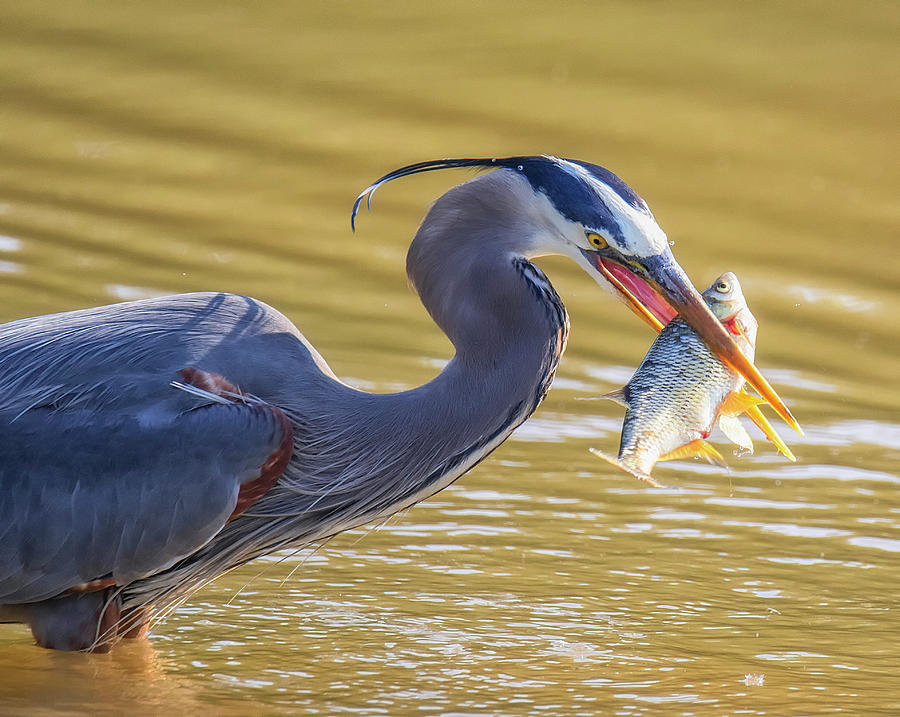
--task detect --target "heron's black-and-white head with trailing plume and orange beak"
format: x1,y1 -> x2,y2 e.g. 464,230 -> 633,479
351,155 -> 800,431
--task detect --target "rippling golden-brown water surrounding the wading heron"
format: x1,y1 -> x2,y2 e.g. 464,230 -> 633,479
0,2 -> 900,716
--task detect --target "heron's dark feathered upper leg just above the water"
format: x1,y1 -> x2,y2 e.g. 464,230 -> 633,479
22,588 -> 122,652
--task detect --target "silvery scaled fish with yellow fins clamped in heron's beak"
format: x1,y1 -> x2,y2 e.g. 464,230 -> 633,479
591,272 -> 796,487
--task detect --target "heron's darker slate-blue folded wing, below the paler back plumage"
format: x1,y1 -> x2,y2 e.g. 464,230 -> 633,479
0,388 -> 290,604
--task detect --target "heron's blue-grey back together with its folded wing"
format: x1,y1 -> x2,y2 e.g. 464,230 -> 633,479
0,293 -> 324,604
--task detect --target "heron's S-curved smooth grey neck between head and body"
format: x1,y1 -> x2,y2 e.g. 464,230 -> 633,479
284,173 -> 569,527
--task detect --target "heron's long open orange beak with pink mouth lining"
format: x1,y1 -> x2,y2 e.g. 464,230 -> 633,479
594,252 -> 803,435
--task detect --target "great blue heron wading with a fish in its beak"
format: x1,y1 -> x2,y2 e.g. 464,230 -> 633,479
0,156 -> 793,651
